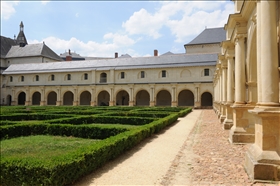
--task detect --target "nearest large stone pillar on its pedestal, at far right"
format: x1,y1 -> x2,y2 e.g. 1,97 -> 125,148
245,0 -> 280,181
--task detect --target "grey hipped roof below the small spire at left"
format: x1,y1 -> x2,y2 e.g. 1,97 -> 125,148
6,43 -> 62,61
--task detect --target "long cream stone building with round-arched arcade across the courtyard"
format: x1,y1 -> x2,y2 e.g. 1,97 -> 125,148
1,22 -> 225,108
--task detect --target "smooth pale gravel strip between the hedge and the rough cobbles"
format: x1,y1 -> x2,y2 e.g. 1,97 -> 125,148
72,110 -> 201,186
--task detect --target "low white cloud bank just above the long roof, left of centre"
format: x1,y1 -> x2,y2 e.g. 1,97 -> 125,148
28,33 -> 138,57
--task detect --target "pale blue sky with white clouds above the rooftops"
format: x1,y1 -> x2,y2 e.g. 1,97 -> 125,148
1,0 -> 234,57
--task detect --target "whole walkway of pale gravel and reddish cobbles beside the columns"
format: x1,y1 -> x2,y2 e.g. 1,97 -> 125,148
74,110 -> 277,186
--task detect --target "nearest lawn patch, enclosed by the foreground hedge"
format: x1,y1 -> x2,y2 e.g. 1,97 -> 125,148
1,135 -> 100,161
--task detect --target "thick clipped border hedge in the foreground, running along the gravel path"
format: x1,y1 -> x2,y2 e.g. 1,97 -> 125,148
1,114 -> 178,186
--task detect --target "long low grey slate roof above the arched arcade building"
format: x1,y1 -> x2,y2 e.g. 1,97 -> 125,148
3,53 -> 218,74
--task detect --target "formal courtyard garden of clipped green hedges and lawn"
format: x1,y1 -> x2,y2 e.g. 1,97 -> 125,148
0,106 -> 191,186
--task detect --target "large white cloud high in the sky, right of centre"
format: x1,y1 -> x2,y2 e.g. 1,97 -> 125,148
122,1 -> 233,42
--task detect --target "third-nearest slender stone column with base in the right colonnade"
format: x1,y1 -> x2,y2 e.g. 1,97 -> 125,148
223,55 -> 234,130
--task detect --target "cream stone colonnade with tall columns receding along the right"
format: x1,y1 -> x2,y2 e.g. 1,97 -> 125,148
213,0 -> 280,181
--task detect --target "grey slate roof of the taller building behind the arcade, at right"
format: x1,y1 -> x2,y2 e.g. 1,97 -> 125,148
185,27 -> 226,46
